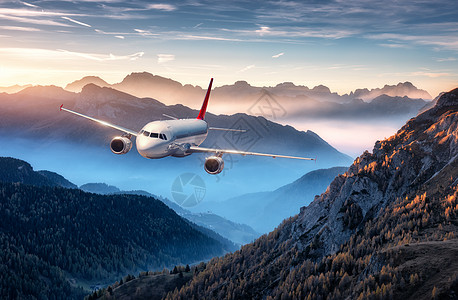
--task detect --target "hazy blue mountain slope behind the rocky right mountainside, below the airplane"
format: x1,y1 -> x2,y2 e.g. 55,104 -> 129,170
200,167 -> 348,233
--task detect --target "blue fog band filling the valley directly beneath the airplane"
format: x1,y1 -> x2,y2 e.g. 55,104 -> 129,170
0,136 -> 344,205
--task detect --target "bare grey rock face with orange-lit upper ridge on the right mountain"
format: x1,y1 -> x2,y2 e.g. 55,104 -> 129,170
285,89 -> 458,258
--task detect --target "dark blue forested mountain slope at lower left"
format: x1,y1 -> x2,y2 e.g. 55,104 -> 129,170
0,158 -> 229,299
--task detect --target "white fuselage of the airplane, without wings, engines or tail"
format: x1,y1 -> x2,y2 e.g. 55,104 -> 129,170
136,119 -> 208,158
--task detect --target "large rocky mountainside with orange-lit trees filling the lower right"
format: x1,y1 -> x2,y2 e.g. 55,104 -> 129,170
150,89 -> 458,299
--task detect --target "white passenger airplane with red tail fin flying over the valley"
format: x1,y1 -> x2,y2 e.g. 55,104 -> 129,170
60,78 -> 316,175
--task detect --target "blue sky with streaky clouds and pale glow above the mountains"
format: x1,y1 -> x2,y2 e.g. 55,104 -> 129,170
0,0 -> 458,97
